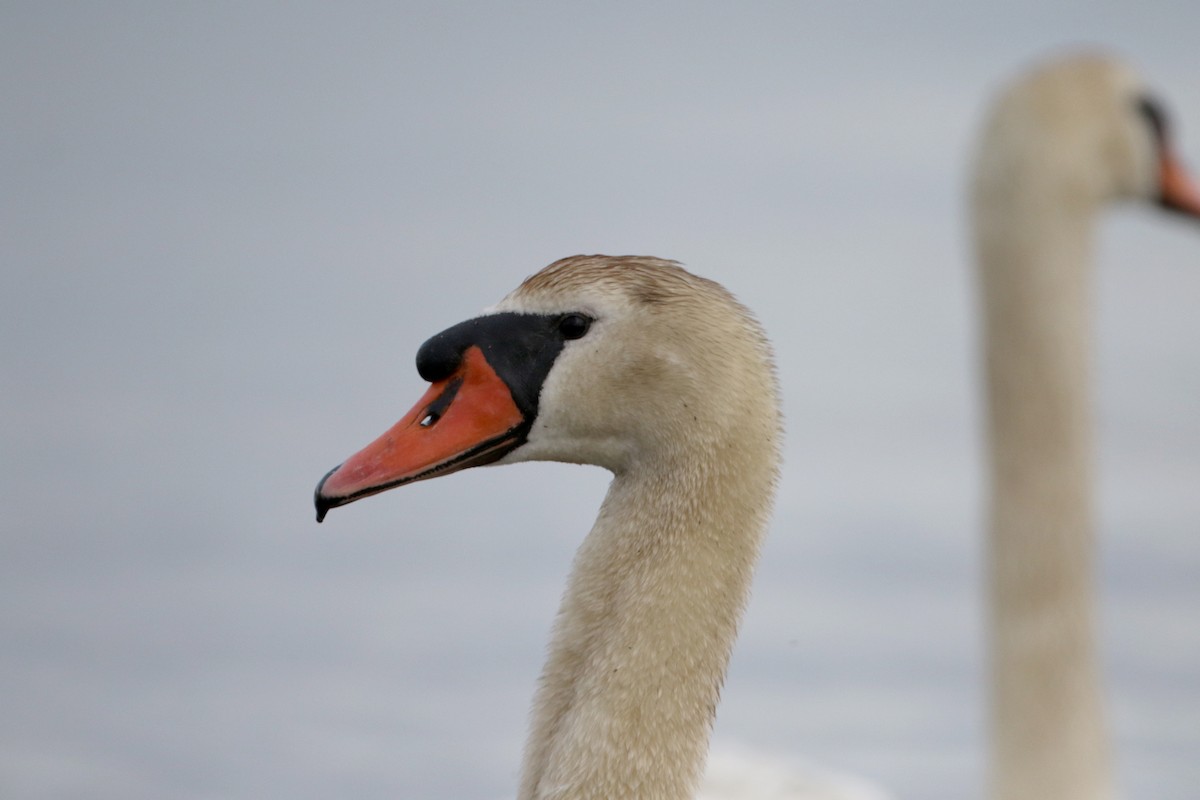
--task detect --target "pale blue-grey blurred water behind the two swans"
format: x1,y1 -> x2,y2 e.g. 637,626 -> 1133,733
0,0 -> 1200,800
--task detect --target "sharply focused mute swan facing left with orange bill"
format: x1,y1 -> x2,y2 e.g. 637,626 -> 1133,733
316,255 -> 880,800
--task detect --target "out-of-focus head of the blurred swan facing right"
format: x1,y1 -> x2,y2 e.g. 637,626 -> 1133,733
974,54 -> 1200,218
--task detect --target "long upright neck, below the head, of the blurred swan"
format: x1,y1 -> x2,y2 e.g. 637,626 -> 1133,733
976,204 -> 1111,800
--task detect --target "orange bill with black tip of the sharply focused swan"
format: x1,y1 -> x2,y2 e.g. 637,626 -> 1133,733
316,345 -> 524,522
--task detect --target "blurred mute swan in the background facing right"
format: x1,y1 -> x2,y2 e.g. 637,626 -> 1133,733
972,55 -> 1200,800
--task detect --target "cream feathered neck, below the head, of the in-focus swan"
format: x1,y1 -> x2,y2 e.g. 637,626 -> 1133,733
518,443 -> 775,800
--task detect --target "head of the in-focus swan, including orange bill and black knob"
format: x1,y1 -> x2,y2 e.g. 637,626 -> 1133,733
314,255 -> 780,522
